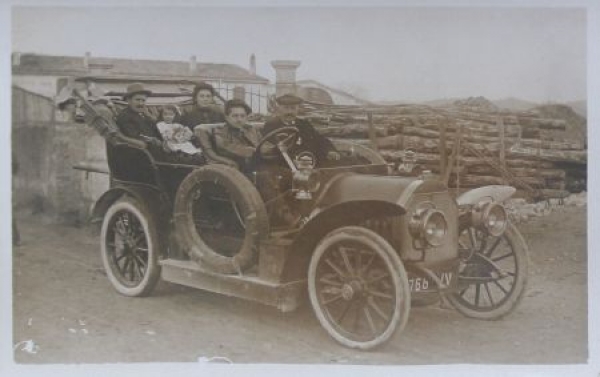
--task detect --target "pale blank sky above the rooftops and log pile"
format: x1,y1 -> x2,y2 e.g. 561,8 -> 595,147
12,7 -> 586,102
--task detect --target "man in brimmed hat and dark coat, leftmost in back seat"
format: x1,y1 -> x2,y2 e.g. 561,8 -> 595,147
116,83 -> 163,147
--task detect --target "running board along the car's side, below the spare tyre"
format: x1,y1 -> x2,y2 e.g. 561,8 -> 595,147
160,259 -> 307,312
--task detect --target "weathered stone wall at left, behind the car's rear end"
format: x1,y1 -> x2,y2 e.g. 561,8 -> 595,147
12,122 -> 108,224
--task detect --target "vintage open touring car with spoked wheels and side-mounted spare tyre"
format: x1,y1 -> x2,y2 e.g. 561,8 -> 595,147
72,89 -> 528,349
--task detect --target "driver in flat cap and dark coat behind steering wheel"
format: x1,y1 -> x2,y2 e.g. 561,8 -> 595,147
262,94 -> 340,164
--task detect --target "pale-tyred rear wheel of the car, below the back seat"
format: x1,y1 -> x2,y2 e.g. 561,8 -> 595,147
100,197 -> 160,296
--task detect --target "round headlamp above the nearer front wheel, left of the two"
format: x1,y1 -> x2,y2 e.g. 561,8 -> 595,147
409,208 -> 448,247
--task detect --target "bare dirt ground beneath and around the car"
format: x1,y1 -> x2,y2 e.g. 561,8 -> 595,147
13,203 -> 588,365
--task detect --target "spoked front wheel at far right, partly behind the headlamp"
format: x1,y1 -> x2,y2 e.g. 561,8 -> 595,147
448,224 -> 529,320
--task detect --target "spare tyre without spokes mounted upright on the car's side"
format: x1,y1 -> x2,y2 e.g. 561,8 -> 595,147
173,164 -> 269,274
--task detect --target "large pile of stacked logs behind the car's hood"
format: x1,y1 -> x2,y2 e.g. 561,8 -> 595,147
303,103 -> 587,196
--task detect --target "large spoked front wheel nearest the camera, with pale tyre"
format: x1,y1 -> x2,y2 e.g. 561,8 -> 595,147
308,226 -> 410,350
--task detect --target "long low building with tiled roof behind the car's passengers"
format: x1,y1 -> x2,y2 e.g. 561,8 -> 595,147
12,52 -> 269,112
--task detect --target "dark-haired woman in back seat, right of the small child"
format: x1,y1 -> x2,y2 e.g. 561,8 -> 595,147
179,82 -> 225,130
